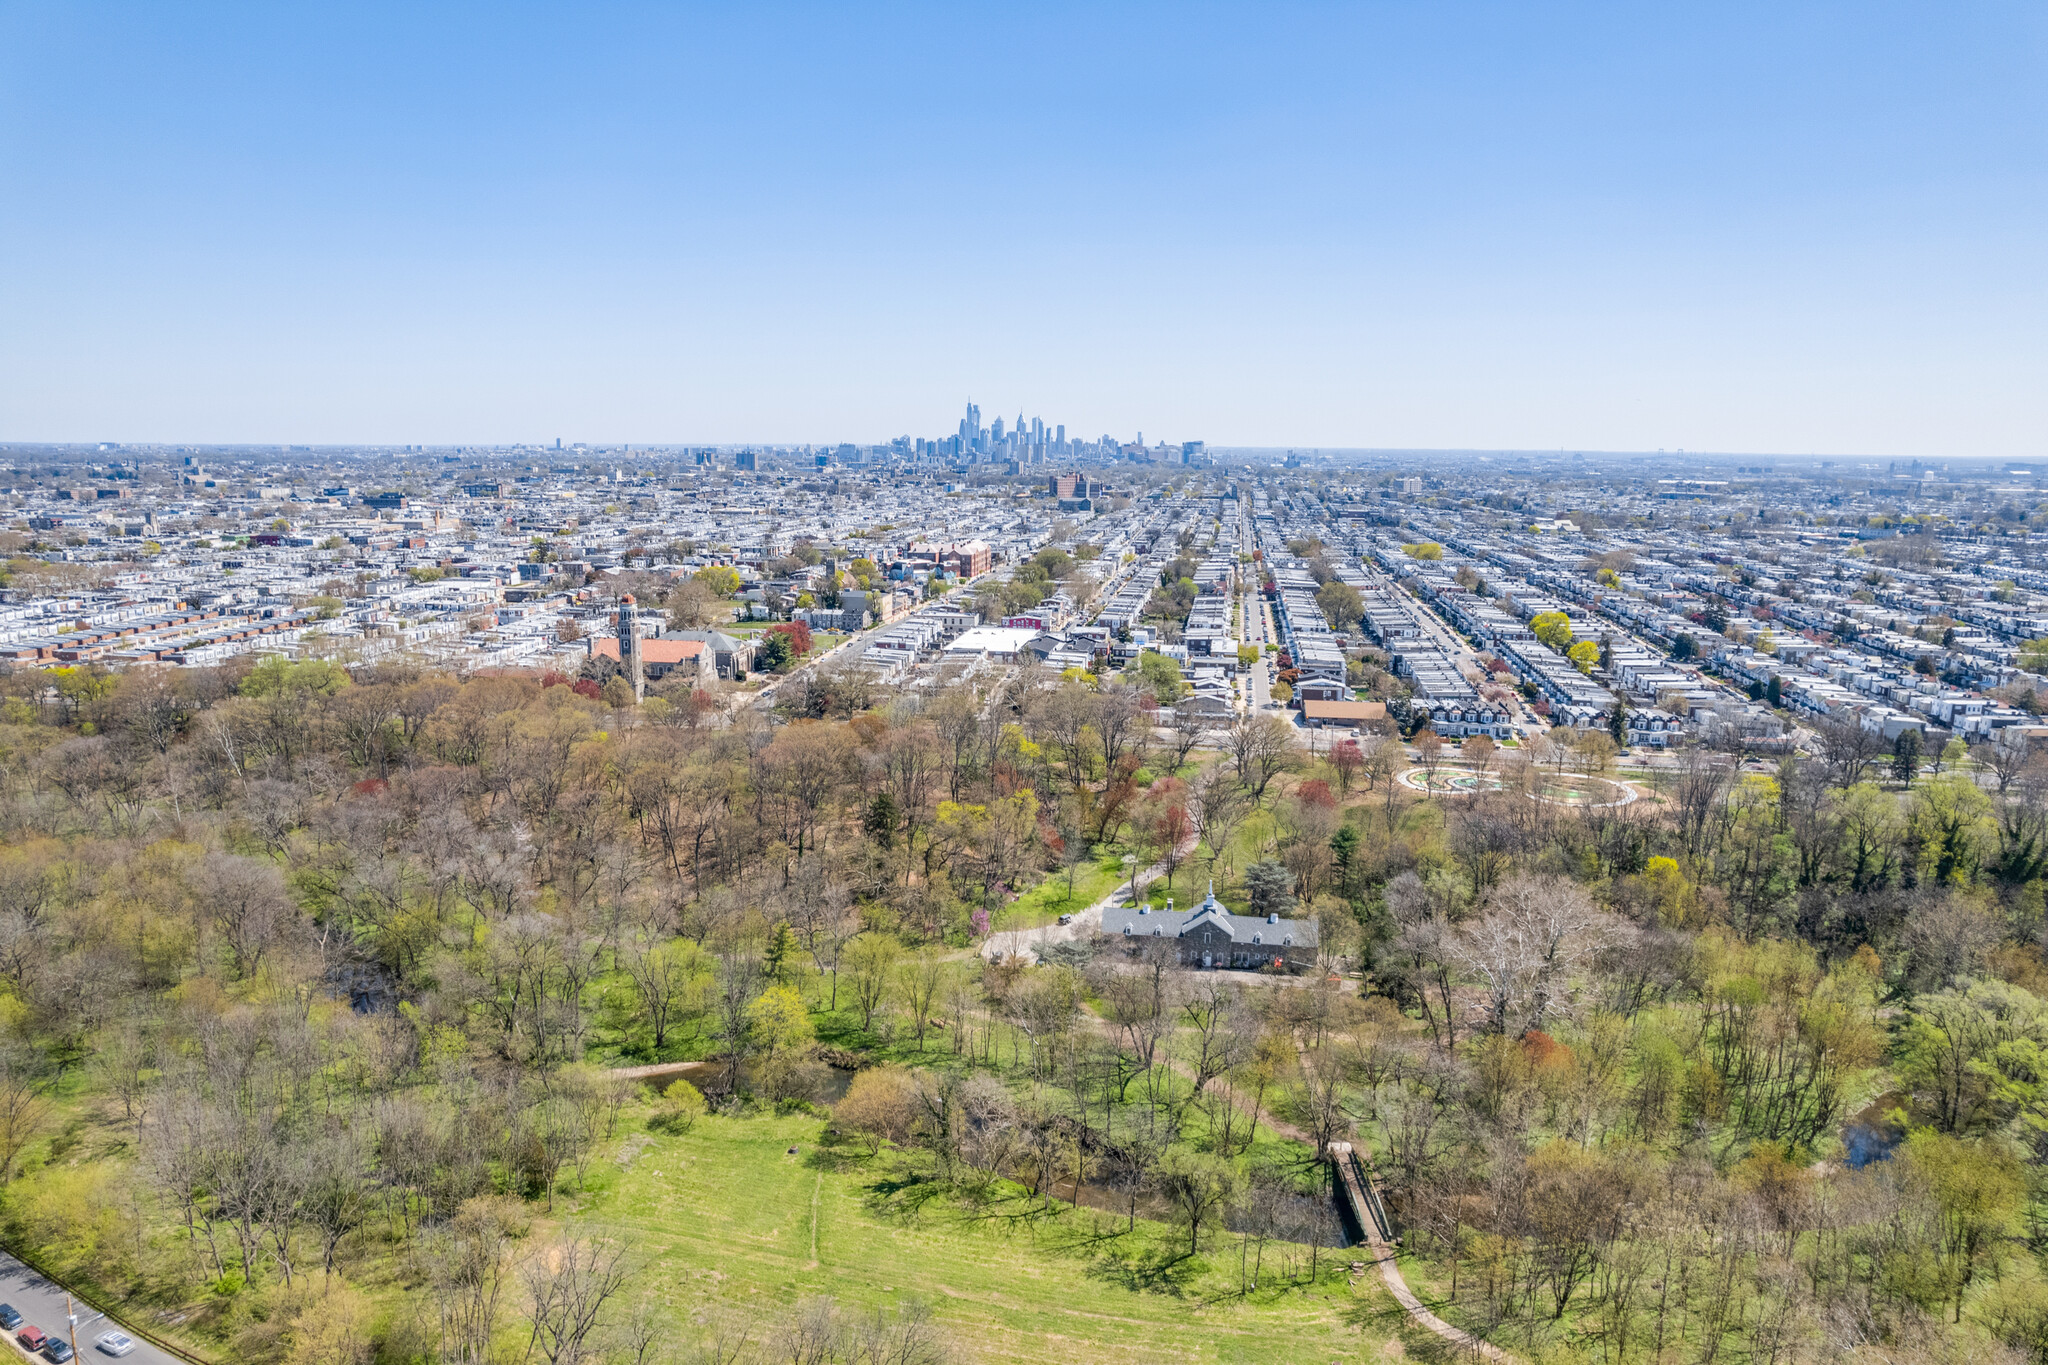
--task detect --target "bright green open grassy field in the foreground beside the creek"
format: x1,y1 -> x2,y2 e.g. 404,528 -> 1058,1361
588,1115 -> 1405,1365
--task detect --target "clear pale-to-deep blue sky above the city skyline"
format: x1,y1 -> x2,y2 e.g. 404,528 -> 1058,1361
0,0 -> 2048,458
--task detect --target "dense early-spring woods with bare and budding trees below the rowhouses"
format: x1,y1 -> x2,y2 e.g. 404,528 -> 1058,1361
0,661 -> 2048,1361
